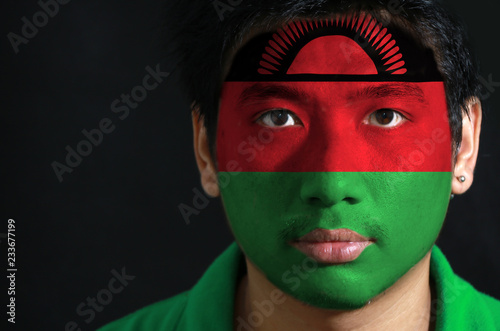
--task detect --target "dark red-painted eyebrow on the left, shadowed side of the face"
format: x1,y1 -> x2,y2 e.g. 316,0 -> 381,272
238,83 -> 309,104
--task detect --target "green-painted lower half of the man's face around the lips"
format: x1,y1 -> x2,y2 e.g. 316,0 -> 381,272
219,172 -> 452,309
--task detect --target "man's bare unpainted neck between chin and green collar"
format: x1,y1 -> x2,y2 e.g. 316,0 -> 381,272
234,252 -> 433,331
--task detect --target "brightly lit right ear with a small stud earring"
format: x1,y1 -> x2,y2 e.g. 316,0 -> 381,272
451,98 -> 482,194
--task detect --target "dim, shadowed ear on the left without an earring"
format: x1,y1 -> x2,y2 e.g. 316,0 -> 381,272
191,109 -> 219,197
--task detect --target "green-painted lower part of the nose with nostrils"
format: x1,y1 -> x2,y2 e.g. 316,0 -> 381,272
300,172 -> 363,207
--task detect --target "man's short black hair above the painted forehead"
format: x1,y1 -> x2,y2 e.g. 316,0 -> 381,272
162,0 -> 481,160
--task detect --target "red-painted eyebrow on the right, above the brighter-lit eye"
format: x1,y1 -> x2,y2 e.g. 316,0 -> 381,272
349,83 -> 427,103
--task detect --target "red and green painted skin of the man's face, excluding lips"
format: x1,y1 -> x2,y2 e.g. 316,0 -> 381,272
217,82 -> 451,309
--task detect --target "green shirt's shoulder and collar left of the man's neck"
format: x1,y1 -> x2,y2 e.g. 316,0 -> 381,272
98,243 -> 244,331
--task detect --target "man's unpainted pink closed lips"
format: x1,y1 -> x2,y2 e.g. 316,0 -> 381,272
290,229 -> 374,264
